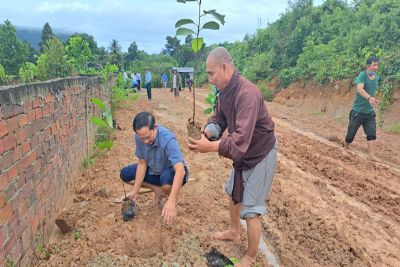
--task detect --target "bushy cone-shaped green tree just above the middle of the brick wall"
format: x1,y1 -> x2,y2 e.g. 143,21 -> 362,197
37,38 -> 71,80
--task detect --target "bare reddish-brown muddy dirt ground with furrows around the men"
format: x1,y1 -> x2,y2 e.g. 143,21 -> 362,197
38,89 -> 400,266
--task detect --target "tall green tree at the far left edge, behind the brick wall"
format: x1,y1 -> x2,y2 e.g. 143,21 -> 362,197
0,20 -> 28,75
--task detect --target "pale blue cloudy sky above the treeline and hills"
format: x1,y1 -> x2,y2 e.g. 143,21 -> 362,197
0,0 -> 323,53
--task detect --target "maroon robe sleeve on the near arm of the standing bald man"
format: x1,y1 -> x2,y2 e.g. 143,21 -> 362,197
218,90 -> 262,162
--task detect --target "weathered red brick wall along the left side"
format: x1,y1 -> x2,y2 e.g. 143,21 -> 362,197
0,77 -> 111,266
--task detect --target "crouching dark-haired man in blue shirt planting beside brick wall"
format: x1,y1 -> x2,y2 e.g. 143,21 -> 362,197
120,112 -> 189,224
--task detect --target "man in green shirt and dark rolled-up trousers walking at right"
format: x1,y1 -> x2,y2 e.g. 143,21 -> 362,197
343,56 -> 379,161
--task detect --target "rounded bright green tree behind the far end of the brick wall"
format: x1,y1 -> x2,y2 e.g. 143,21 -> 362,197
65,36 -> 92,73
